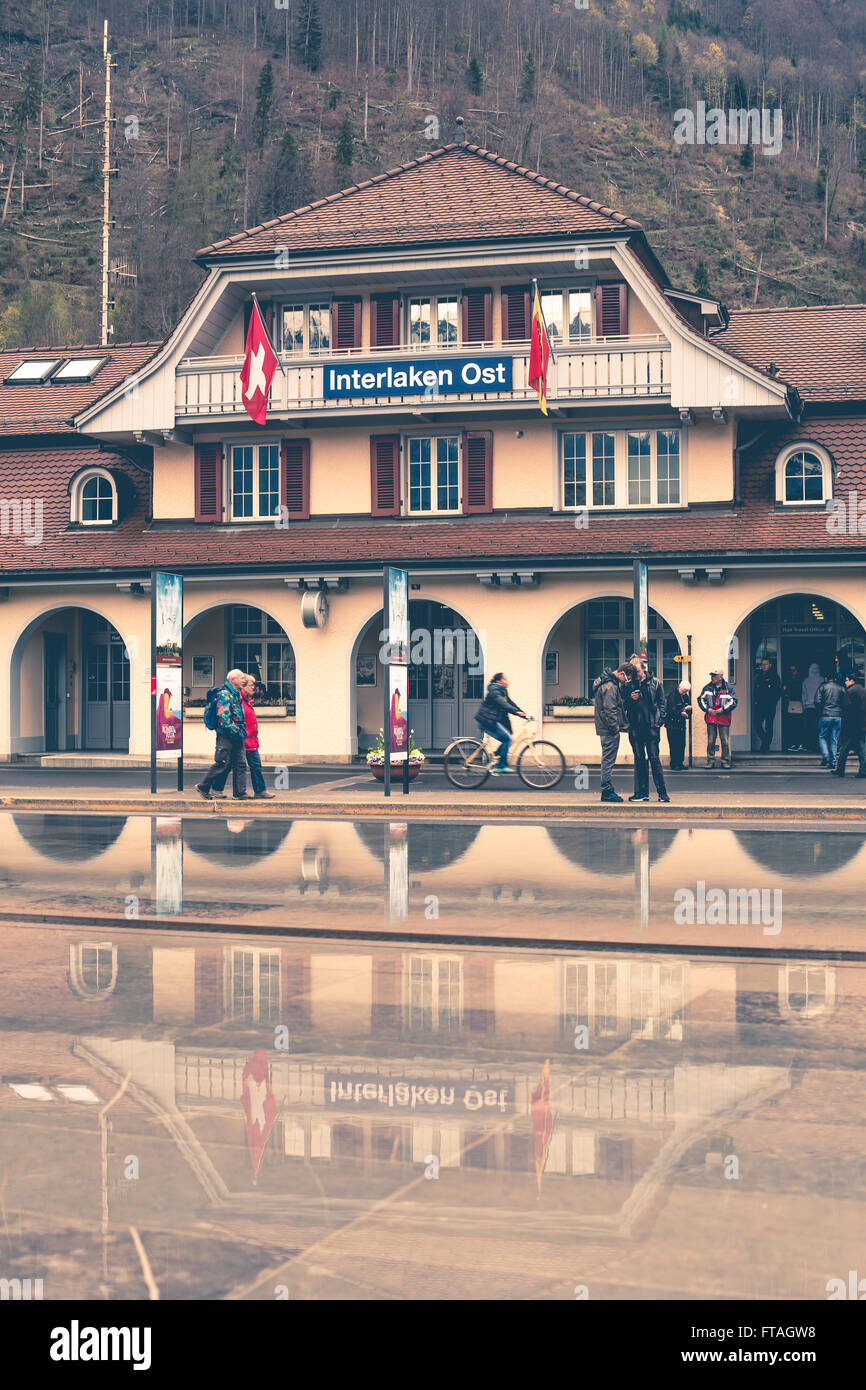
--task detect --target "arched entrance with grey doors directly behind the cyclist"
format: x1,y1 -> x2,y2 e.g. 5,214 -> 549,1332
352,599 -> 484,752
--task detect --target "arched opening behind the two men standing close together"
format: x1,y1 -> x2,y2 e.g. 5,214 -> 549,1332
544,595 -> 681,706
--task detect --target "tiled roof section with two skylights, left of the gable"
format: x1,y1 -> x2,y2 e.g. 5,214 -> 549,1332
0,343 -> 161,435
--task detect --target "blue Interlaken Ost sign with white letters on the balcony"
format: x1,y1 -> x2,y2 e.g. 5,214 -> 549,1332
322,357 -> 512,400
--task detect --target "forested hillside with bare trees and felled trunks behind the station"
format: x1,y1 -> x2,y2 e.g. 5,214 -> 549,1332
0,0 -> 866,346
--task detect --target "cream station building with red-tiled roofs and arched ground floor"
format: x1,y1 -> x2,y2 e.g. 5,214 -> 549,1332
0,145 -> 866,762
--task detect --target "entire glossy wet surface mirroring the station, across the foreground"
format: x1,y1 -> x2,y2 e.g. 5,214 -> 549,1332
0,813 -> 866,1301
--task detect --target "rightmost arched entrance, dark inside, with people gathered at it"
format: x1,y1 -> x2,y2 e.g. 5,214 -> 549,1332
730,592 -> 866,755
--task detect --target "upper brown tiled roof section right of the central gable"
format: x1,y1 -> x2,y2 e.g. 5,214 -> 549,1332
716,304 -> 866,402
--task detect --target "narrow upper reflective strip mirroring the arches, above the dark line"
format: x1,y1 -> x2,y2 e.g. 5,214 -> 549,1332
0,813 -> 866,951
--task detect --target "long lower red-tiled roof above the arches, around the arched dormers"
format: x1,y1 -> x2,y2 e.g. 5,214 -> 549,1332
0,420 -> 866,573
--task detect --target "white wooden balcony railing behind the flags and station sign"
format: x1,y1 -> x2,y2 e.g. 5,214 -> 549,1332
175,335 -> 670,418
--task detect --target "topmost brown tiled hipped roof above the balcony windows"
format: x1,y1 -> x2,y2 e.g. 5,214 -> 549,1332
199,145 -> 641,260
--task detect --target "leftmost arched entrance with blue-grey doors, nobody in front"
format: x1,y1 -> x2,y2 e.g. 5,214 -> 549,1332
10,607 -> 131,753
